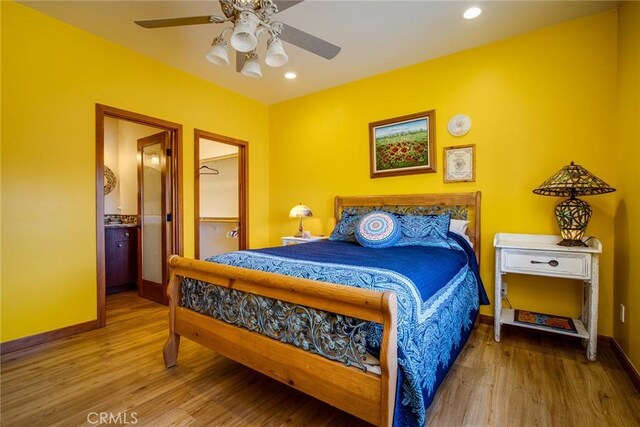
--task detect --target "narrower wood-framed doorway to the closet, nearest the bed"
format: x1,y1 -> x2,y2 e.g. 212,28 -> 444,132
194,129 -> 249,259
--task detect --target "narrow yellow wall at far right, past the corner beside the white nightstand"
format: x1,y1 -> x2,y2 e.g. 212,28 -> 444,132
613,2 -> 640,370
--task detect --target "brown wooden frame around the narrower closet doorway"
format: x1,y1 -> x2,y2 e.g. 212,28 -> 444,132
193,129 -> 249,259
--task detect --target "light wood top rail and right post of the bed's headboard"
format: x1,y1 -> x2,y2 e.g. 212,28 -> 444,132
334,191 -> 481,263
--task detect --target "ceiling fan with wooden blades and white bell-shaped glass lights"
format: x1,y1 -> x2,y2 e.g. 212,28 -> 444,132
134,0 -> 340,77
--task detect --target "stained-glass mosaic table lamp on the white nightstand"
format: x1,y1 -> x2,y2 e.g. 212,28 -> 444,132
533,162 -> 616,246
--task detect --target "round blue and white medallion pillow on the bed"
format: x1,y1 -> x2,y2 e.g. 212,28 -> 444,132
355,211 -> 402,248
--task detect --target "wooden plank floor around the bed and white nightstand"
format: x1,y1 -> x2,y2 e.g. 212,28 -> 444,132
0,293 -> 640,427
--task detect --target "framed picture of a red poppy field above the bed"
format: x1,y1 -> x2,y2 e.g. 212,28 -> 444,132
369,110 -> 436,178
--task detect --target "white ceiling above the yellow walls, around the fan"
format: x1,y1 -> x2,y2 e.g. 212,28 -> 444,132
20,0 -> 619,104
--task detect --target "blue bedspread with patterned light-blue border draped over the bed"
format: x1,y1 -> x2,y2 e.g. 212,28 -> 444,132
209,233 -> 488,426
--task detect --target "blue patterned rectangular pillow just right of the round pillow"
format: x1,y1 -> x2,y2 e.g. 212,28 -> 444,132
396,214 -> 451,249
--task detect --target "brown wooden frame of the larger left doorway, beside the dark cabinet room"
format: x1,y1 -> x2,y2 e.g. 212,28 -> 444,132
96,104 -> 184,328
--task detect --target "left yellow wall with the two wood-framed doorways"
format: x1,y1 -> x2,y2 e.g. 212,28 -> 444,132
0,2 -> 269,342
